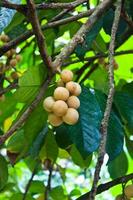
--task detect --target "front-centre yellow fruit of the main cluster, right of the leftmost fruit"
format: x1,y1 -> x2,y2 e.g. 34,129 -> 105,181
52,100 -> 68,117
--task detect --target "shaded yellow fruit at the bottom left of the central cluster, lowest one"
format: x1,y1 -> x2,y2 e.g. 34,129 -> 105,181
48,113 -> 63,126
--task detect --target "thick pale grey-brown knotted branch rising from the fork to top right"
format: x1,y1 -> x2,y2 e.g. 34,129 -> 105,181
53,0 -> 113,68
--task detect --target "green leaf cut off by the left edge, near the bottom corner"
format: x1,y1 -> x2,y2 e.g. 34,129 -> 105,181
0,155 -> 8,190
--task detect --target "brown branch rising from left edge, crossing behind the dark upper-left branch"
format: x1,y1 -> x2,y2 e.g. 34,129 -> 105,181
0,9 -> 94,56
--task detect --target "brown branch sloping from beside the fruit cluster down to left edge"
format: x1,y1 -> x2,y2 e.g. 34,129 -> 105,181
0,77 -> 52,145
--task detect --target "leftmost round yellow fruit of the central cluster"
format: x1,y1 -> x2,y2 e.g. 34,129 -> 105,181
43,96 -> 55,112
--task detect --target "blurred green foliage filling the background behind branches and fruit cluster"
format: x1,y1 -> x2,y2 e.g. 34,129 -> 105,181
0,0 -> 133,200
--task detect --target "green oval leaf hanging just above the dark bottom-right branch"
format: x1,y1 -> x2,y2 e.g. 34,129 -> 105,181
108,152 -> 128,179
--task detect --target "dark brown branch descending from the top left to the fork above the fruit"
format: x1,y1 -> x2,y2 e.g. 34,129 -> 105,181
27,0 -> 52,71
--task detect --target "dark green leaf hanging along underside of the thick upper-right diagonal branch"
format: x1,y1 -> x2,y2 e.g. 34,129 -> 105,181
75,18 -> 103,59
